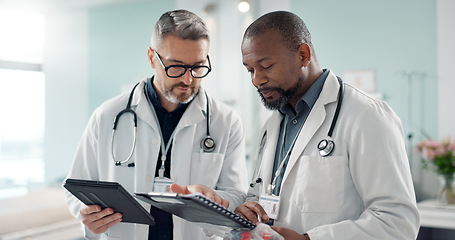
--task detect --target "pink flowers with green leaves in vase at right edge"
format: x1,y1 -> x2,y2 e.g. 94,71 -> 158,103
417,139 -> 455,204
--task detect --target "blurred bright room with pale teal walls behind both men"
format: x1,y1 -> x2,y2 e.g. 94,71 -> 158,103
0,0 -> 455,239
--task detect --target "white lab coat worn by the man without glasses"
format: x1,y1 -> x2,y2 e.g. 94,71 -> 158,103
249,72 -> 419,240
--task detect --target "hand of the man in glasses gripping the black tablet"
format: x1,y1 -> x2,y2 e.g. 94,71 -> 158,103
79,205 -> 122,234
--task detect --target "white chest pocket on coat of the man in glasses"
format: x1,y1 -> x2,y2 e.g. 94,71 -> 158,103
190,152 -> 224,188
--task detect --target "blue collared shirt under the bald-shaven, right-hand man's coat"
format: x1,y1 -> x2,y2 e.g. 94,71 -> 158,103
272,69 -> 330,196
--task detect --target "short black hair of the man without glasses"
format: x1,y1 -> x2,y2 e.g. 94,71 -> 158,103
243,11 -> 314,54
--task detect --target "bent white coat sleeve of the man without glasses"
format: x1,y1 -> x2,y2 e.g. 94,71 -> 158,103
308,102 -> 420,240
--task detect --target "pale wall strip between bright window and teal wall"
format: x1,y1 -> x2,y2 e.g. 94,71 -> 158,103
43,11 -> 89,183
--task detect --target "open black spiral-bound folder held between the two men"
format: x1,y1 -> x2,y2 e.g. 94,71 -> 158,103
135,192 -> 256,229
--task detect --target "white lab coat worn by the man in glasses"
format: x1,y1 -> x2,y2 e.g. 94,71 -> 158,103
67,81 -> 248,240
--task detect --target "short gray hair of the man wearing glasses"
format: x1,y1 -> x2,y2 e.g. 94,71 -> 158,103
151,10 -> 210,49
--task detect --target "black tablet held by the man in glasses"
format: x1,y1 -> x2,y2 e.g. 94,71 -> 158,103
63,178 -> 155,226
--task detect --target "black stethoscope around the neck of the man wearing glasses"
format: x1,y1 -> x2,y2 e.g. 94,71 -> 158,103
111,80 -> 216,167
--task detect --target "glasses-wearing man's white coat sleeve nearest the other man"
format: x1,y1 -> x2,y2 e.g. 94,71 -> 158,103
216,115 -> 248,210
